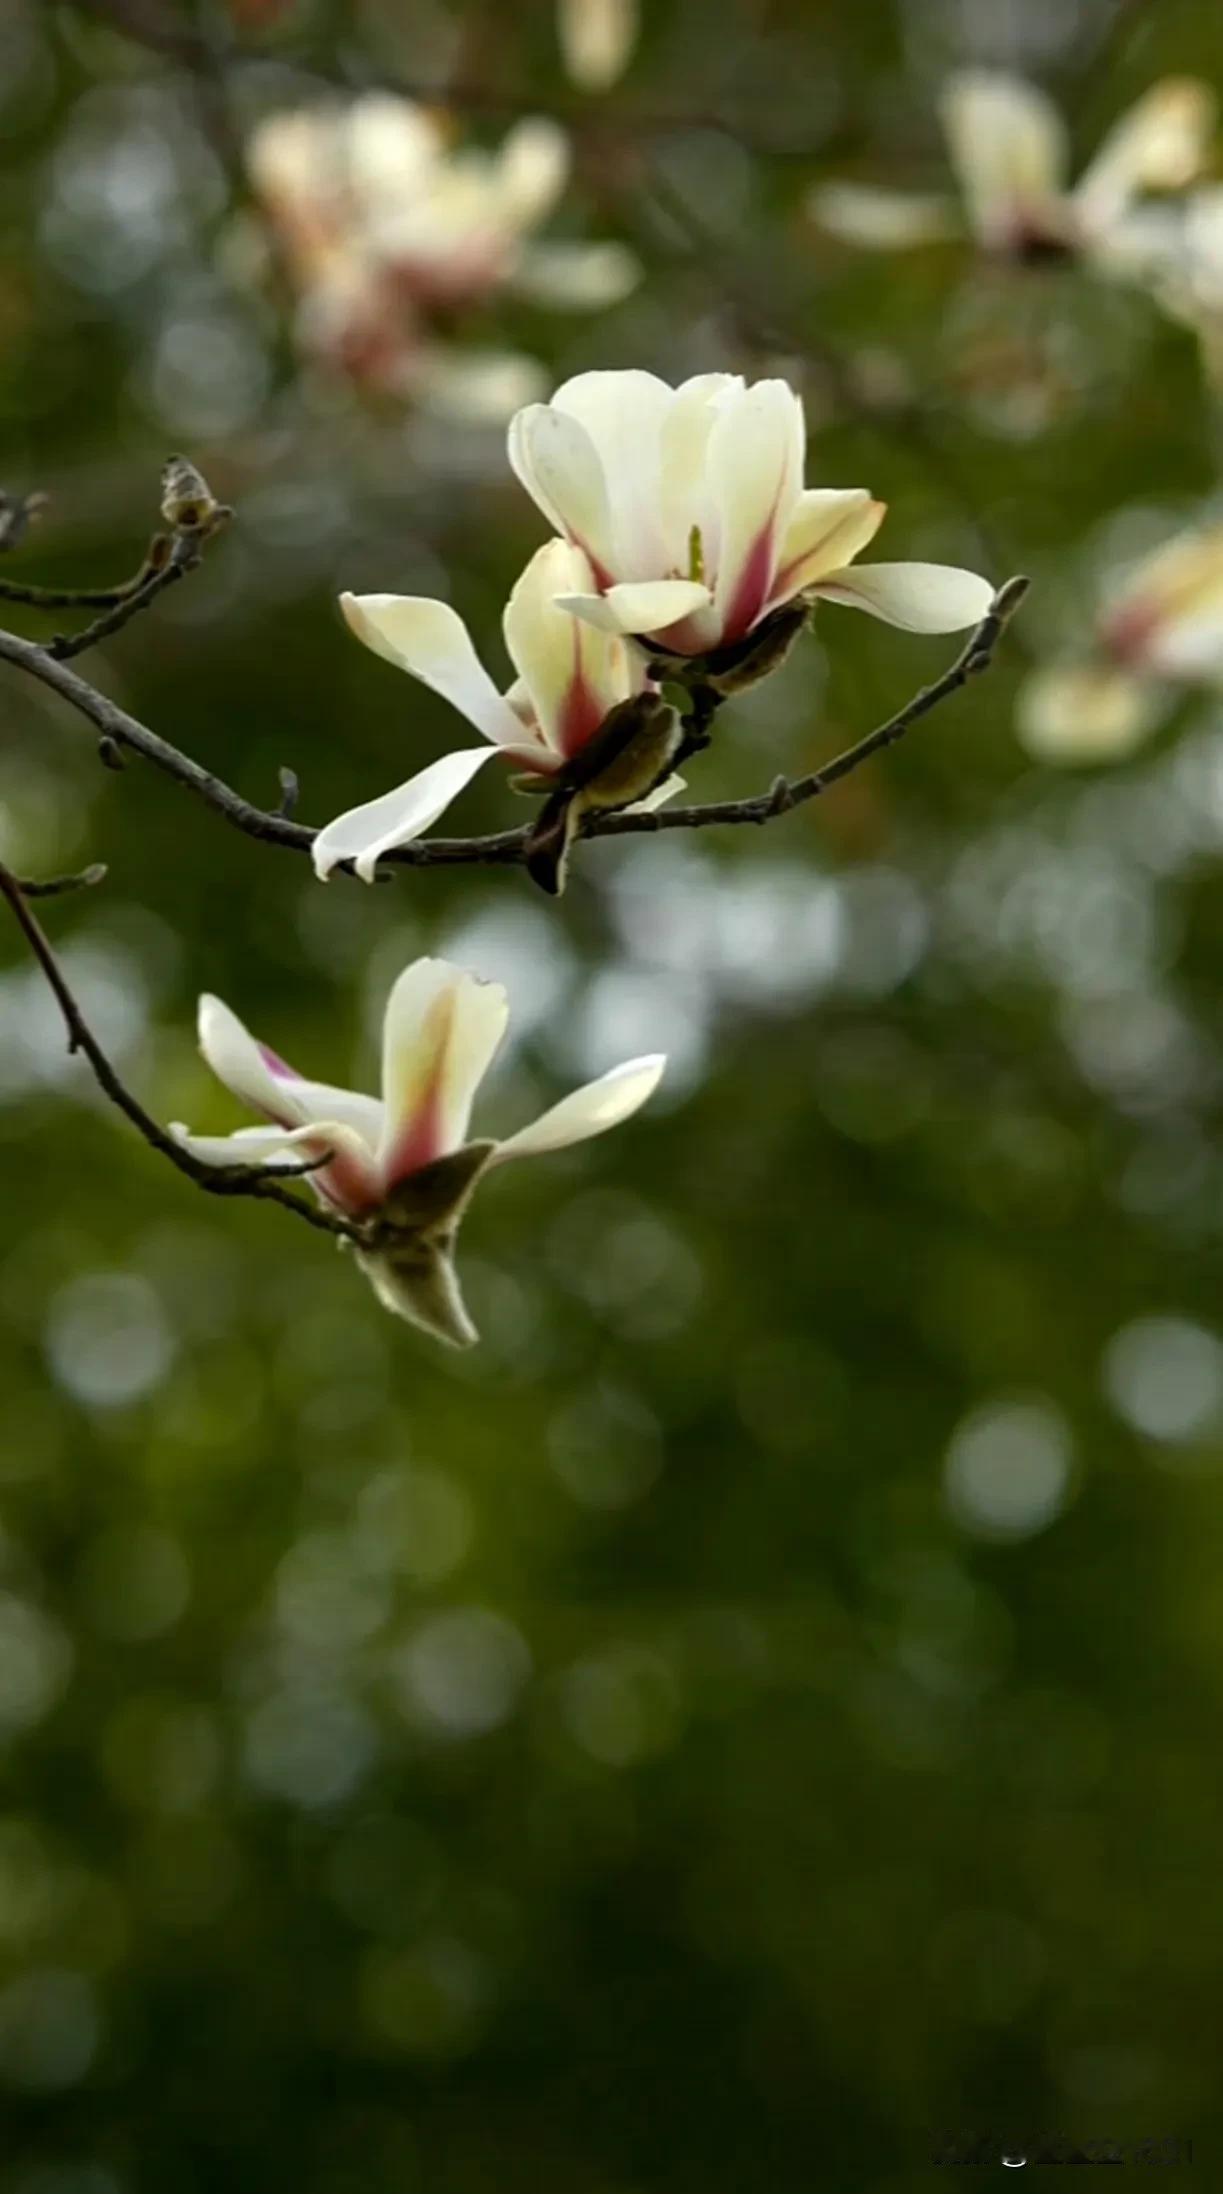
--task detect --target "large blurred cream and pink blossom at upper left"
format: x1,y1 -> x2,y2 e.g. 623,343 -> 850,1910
248,92 -> 637,417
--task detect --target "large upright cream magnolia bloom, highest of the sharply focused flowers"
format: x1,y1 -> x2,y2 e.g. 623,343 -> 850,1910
509,373 -> 992,654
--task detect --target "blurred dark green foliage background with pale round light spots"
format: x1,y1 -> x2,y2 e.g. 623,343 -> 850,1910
0,0 -> 1223,2194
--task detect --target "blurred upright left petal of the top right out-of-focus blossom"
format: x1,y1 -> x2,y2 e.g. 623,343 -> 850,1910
940,68 -> 1069,250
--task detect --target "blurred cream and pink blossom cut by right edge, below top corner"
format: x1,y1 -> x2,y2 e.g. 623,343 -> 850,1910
1017,527 -> 1223,764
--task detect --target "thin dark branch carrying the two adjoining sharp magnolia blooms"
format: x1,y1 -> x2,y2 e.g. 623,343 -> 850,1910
0,579 -> 1028,869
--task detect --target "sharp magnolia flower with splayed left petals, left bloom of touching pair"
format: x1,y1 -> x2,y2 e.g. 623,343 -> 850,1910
312,542 -> 678,889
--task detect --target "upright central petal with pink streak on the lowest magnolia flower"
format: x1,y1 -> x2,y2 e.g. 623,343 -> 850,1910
371,959 -> 509,1189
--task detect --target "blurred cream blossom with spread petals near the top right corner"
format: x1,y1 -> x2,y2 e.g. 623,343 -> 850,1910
808,68 -> 1214,259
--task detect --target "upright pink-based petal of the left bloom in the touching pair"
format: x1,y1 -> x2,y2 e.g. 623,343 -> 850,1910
505,540 -> 632,757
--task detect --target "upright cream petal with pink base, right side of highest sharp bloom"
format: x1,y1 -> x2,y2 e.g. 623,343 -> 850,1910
707,380 -> 806,641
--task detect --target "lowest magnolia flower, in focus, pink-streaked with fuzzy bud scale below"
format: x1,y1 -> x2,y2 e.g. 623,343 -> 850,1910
171,959 -> 665,1347
